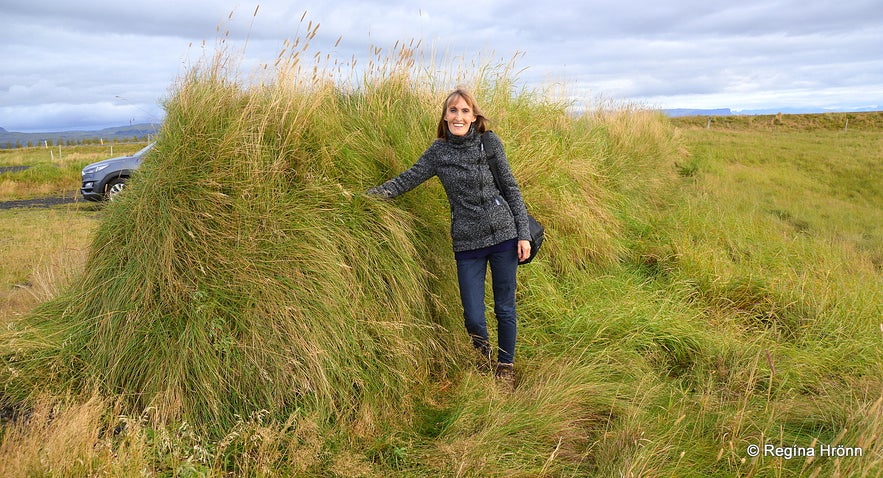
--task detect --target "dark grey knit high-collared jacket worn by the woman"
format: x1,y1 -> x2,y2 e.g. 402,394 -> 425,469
369,131 -> 530,252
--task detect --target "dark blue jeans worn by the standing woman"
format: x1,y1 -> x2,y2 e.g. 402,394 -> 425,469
457,249 -> 518,363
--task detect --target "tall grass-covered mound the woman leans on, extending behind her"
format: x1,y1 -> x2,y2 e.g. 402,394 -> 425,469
5,41 -> 670,428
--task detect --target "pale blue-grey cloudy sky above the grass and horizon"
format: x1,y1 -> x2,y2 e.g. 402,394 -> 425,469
0,0 -> 883,132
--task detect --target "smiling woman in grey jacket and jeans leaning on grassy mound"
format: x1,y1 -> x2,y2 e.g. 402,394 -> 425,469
368,88 -> 531,389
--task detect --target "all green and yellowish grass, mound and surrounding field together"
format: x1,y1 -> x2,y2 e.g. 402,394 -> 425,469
0,39 -> 883,477
